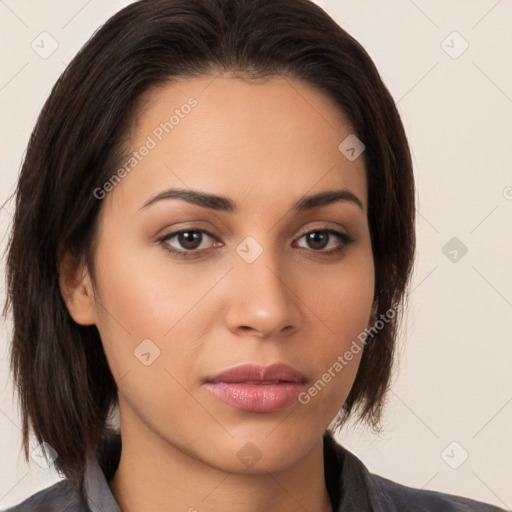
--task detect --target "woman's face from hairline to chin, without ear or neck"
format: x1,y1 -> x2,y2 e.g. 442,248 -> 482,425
81,76 -> 374,472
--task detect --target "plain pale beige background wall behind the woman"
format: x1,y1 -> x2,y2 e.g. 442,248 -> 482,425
0,0 -> 512,508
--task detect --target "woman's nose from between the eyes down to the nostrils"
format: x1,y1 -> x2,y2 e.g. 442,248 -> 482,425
226,244 -> 301,338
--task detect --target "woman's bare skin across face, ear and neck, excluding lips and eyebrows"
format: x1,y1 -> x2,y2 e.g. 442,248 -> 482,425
61,75 -> 374,512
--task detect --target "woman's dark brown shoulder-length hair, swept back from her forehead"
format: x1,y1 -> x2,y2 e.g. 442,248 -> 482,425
4,0 -> 415,504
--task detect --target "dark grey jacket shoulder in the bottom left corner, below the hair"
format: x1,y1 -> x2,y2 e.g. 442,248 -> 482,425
3,480 -> 90,512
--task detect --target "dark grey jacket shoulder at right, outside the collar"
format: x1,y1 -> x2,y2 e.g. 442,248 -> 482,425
369,473 -> 504,512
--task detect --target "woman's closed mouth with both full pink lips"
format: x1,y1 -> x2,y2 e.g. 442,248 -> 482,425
205,363 -> 307,412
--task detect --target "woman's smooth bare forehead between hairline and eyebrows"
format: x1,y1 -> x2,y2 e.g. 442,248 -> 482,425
107,76 -> 367,216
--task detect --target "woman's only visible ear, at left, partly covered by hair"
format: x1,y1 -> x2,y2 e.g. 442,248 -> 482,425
59,252 -> 96,325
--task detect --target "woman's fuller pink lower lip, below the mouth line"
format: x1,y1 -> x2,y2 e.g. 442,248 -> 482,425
207,382 -> 305,412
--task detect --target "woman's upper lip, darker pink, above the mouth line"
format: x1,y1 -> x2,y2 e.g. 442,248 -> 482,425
207,363 -> 306,383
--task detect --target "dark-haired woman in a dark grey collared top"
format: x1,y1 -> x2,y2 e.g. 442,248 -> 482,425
3,0 -> 508,512
